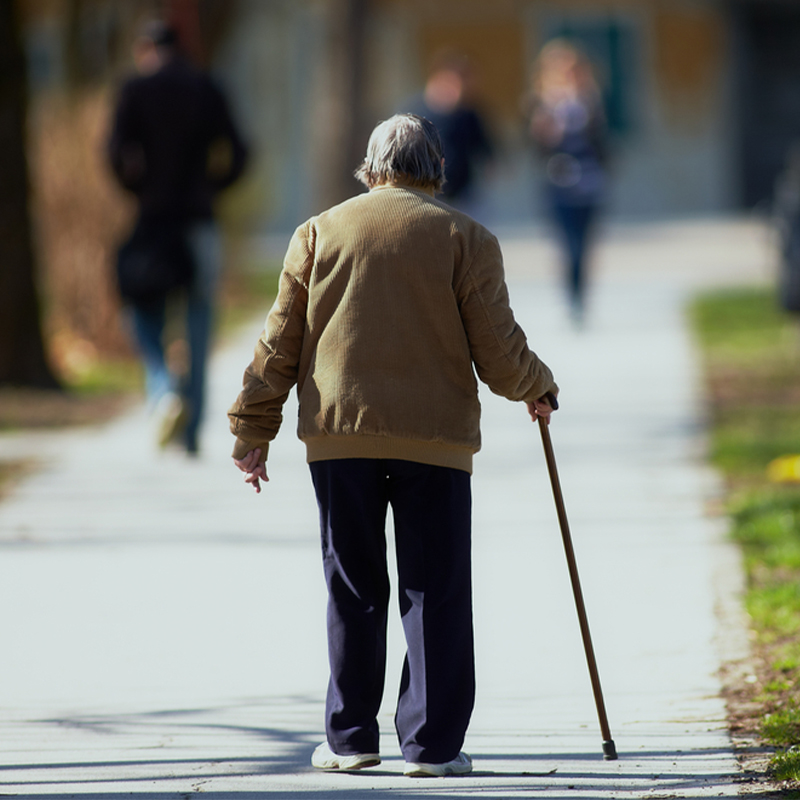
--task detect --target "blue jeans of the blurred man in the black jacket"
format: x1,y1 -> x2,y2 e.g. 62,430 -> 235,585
133,221 -> 222,453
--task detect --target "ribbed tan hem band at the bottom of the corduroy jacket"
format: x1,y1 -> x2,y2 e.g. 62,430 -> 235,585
303,434 -> 473,475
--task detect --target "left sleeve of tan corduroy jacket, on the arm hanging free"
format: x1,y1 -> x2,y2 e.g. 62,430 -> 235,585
228,221 -> 314,460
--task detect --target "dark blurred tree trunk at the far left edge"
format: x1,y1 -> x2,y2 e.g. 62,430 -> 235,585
0,0 -> 58,388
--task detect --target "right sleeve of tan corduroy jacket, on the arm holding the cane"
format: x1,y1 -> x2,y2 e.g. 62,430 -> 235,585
457,236 -> 558,402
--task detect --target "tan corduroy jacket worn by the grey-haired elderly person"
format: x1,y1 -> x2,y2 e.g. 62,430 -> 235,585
229,185 -> 558,472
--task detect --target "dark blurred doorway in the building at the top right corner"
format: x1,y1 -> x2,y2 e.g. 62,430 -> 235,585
733,0 -> 800,207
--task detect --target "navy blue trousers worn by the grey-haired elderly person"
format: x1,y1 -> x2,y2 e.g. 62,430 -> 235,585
310,459 -> 475,764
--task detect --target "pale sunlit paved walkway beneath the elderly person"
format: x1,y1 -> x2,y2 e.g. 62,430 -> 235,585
0,216 -> 770,800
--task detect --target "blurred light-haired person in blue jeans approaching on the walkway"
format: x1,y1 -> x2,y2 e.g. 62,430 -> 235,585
528,39 -> 607,322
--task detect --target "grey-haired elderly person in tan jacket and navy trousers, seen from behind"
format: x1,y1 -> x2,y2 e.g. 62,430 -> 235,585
229,114 -> 558,777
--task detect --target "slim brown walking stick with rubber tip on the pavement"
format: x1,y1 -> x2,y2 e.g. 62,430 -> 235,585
539,394 -> 617,761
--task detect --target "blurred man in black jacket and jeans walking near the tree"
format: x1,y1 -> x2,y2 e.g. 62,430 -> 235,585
108,22 -> 246,454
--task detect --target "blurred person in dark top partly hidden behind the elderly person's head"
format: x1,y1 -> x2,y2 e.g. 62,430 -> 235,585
402,52 -> 492,209
